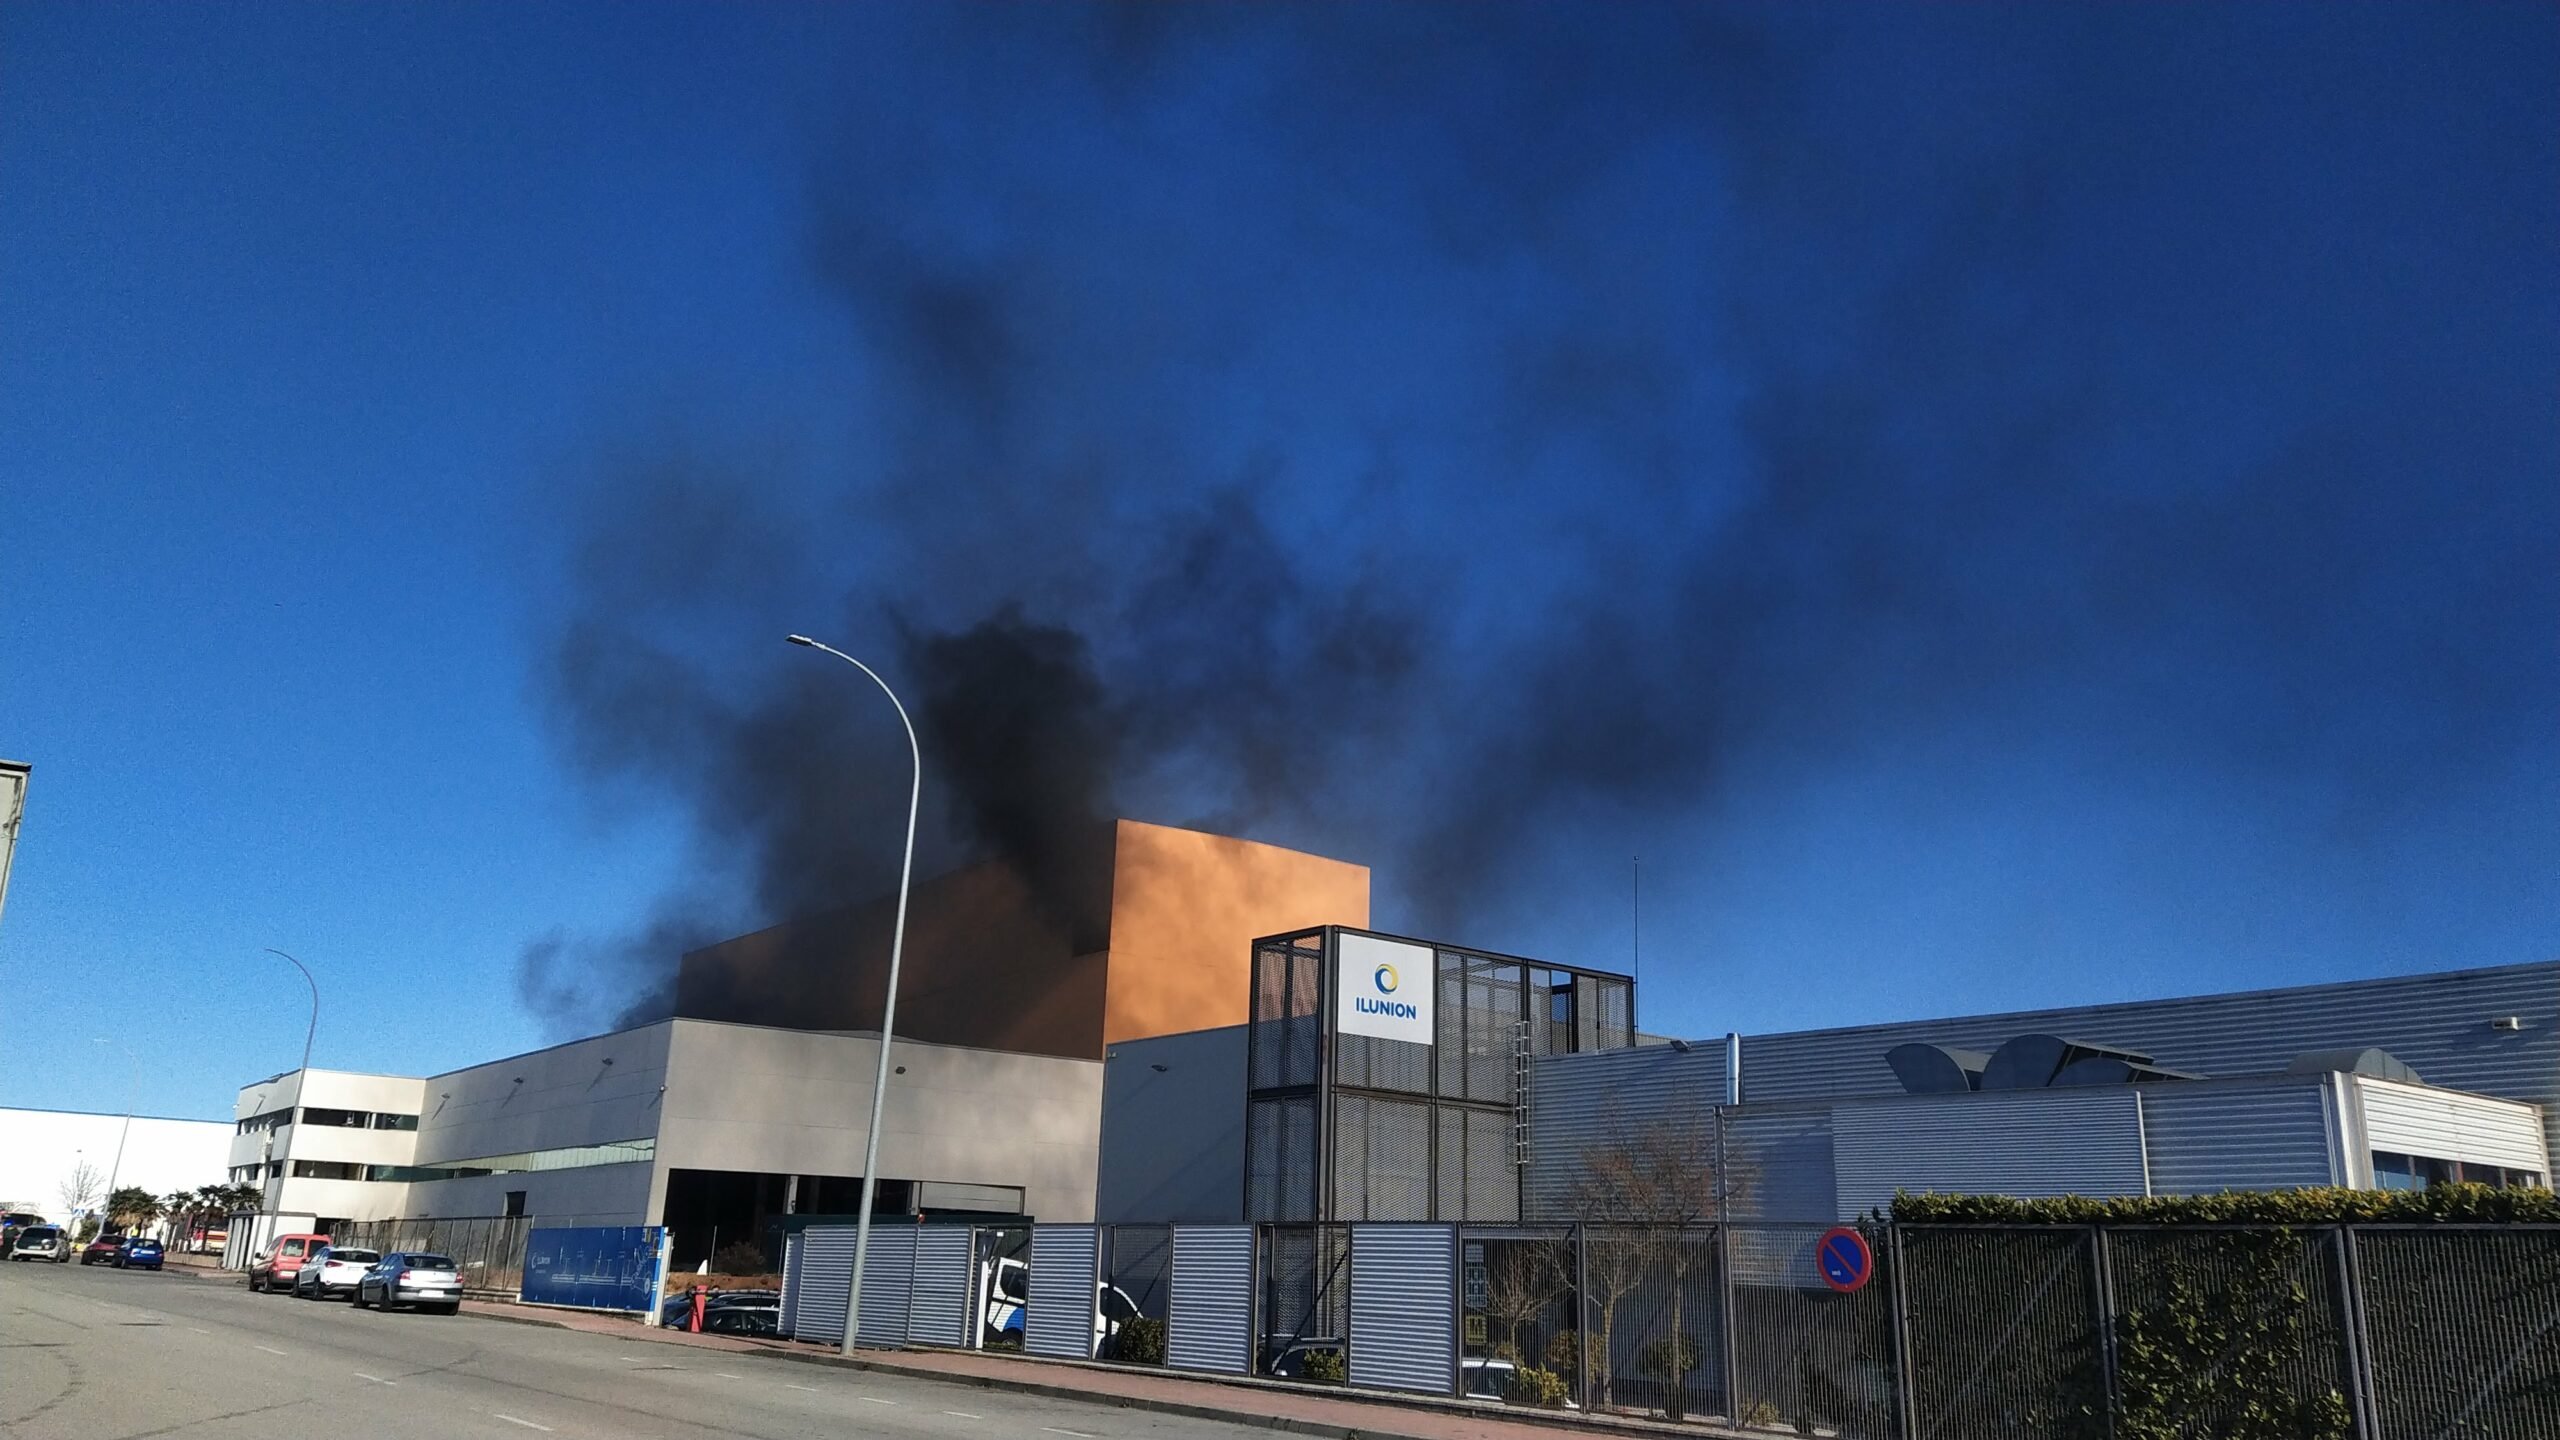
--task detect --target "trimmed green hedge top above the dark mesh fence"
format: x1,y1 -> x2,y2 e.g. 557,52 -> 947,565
1892,1184 -> 2560,1225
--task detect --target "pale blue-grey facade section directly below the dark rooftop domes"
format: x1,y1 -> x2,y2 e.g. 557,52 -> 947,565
1830,1086 -> 2145,1220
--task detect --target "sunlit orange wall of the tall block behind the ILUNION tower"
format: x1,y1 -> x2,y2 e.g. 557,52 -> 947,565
1103,820 -> 1370,1045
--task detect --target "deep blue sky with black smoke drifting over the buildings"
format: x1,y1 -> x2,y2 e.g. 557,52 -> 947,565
0,5 -> 2560,1115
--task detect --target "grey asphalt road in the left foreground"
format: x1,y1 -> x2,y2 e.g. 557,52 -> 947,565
0,1263 -> 1270,1440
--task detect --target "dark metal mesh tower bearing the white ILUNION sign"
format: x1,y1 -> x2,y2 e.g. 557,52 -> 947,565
1244,925 -> 1636,1225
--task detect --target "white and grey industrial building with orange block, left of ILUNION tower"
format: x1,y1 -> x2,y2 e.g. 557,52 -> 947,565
230,820 -> 1370,1263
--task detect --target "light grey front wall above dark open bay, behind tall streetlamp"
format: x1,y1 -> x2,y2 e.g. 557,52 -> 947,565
648,1020 -> 1103,1222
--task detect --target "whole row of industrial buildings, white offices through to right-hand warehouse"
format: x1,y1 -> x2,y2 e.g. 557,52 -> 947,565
230,799 -> 2560,1263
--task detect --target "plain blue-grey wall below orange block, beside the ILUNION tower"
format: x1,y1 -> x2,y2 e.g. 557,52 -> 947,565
1093,1025 -> 1244,1225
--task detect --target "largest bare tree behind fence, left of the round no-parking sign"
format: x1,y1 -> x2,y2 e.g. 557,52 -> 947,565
1569,1112 -> 1748,1420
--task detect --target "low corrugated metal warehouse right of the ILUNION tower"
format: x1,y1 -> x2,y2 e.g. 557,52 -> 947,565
1523,963 -> 2560,1220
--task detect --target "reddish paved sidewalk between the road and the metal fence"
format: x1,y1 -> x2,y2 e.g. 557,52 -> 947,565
468,1302 -> 1784,1440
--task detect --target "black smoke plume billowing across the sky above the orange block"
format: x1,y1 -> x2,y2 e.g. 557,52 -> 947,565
525,5 -> 2560,1022
